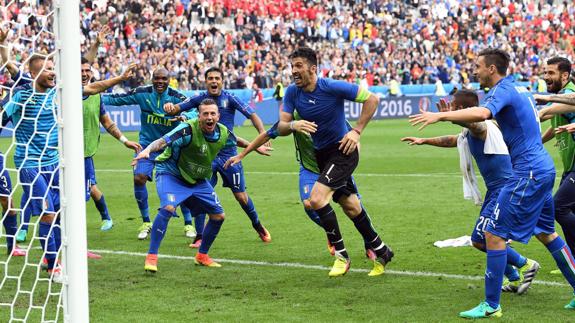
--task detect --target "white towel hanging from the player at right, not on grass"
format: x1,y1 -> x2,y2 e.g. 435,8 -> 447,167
457,129 -> 482,205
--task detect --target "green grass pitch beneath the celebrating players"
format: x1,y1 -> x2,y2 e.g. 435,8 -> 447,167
0,120 -> 574,322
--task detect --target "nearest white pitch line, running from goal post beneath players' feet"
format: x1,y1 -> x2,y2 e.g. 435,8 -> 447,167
90,250 -> 569,287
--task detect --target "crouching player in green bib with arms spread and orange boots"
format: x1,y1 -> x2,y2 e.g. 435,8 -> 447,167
134,99 -> 272,272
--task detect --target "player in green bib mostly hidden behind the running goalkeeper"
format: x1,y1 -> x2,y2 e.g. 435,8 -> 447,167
224,113 -> 378,269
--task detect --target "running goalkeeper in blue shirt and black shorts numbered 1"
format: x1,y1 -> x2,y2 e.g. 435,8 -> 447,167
277,47 -> 393,277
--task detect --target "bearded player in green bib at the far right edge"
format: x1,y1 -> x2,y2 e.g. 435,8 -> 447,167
539,57 -> 575,274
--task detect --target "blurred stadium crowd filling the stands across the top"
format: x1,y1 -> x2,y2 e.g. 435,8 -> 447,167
0,0 -> 575,89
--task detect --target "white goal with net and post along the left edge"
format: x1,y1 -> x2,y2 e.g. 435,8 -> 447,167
0,0 -> 89,322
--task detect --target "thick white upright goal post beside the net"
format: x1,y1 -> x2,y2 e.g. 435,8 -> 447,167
54,0 -> 89,322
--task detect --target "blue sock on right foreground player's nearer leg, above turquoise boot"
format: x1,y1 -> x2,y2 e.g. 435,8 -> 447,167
485,249 -> 507,308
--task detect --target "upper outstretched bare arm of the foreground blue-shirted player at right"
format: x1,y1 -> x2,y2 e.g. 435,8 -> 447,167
409,107 -> 491,130
